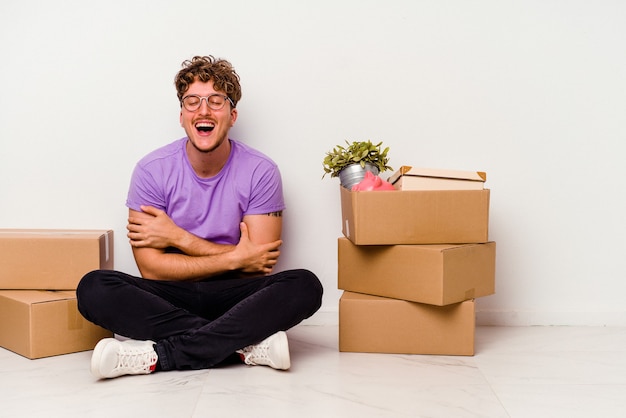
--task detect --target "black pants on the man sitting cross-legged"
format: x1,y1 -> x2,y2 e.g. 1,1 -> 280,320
76,270 -> 322,370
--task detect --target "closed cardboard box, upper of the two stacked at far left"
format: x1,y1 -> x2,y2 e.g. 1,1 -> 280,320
0,229 -> 113,290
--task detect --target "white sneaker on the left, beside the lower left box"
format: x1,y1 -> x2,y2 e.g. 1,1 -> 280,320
91,338 -> 158,379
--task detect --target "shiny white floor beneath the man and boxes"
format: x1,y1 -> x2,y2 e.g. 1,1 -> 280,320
0,325 -> 626,418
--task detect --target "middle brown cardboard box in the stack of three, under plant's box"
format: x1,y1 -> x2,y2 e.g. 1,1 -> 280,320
338,238 -> 496,306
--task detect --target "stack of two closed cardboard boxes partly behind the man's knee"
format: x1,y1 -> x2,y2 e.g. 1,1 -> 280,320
0,229 -> 113,359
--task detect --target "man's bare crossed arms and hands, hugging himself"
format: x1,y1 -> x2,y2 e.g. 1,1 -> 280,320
127,206 -> 282,280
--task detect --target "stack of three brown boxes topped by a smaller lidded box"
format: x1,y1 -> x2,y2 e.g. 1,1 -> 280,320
338,167 -> 496,355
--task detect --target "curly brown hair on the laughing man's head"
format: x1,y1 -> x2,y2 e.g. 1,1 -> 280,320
174,55 -> 241,107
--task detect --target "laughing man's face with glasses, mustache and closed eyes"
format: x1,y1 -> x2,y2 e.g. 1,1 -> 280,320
180,80 -> 237,153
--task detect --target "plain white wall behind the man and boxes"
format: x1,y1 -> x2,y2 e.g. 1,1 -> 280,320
0,0 -> 626,326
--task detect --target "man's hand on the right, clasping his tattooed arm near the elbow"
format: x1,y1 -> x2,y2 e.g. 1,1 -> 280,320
232,222 -> 283,274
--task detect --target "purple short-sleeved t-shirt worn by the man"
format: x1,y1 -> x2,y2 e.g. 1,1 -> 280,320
126,137 -> 285,244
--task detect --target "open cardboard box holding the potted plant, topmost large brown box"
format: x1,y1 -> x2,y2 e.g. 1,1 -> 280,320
339,186 -> 489,245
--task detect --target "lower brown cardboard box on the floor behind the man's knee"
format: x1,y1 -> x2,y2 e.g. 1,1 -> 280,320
0,290 -> 113,359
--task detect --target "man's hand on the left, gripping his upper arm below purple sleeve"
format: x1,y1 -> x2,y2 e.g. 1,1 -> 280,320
126,206 -> 182,249
